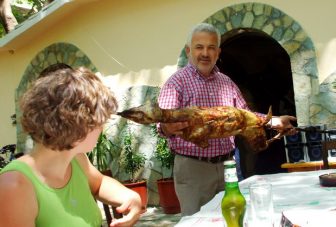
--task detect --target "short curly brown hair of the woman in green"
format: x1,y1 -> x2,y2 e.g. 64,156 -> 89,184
21,68 -> 117,151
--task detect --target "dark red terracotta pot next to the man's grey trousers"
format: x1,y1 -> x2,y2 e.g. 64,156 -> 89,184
157,178 -> 181,214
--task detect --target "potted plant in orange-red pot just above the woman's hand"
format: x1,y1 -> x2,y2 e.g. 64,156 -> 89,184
121,130 -> 148,213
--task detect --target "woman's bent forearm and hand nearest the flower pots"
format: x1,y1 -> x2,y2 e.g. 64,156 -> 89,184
76,154 -> 141,226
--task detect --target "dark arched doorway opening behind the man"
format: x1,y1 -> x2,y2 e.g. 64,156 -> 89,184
217,28 -> 296,177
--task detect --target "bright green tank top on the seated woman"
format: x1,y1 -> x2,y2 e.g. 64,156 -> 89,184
0,159 -> 102,227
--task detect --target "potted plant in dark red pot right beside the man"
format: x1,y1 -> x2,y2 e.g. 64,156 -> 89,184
153,125 -> 181,214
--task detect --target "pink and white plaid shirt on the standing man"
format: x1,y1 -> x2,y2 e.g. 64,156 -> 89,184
158,63 -> 248,157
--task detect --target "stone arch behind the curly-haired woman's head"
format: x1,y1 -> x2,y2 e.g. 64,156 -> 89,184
15,43 -> 97,152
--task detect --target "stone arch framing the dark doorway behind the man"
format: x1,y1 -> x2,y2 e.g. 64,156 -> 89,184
177,2 -> 318,125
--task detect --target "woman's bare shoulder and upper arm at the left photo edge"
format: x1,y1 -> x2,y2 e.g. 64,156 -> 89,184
0,171 -> 38,227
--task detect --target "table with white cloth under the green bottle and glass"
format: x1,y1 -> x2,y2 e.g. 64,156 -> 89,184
175,169 -> 336,227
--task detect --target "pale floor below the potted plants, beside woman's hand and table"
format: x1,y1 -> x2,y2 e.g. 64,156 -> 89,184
101,206 -> 181,227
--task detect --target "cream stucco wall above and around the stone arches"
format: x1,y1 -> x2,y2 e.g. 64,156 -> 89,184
0,0 -> 336,146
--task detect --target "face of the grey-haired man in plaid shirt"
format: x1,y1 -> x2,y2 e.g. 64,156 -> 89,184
186,32 -> 220,77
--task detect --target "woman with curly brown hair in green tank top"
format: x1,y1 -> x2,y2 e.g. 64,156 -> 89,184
0,68 -> 141,227
